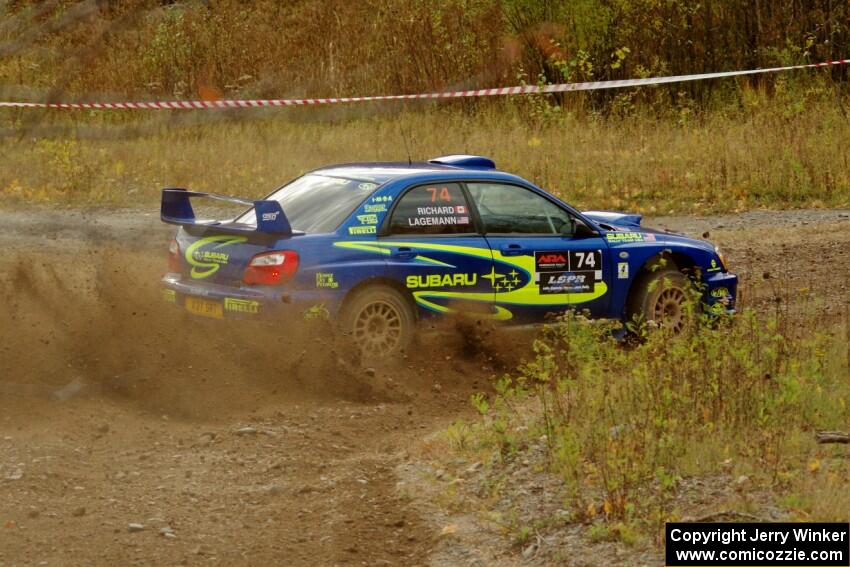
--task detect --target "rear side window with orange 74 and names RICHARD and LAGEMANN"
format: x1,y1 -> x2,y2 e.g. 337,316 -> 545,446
390,183 -> 475,234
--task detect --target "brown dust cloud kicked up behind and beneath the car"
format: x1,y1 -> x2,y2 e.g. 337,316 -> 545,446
0,244 -> 514,419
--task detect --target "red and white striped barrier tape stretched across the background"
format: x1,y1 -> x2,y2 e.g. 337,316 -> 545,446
0,59 -> 850,110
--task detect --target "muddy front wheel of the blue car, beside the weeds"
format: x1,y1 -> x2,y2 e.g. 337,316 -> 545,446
626,268 -> 693,333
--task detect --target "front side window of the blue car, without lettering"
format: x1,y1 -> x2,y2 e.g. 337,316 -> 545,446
467,183 -> 570,235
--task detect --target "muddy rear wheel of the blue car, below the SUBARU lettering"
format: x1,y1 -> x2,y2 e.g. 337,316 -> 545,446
340,285 -> 416,357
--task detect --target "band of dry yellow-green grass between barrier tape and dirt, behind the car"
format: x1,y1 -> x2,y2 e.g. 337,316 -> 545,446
0,89 -> 850,214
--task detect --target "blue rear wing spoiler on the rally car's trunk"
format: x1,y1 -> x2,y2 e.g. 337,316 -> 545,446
160,188 -> 292,236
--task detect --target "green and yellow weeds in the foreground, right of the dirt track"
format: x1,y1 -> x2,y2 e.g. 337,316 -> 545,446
438,300 -> 850,542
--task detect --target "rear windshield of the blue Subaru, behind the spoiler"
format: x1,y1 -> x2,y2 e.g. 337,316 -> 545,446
236,173 -> 378,233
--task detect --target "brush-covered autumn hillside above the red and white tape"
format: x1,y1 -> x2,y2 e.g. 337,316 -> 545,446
0,0 -> 850,104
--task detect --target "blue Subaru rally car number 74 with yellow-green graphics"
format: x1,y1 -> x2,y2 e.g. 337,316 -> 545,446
162,156 -> 737,356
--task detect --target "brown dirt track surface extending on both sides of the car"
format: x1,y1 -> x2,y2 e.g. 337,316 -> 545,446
0,206 -> 850,565
